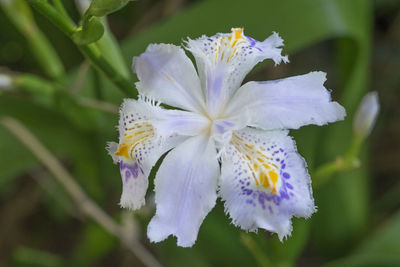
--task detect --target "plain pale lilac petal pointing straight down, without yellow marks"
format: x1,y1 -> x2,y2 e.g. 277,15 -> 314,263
147,136 -> 219,247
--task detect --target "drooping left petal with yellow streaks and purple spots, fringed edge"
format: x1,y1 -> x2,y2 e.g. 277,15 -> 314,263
108,98 -> 194,209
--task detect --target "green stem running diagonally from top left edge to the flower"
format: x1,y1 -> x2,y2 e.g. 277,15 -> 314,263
28,0 -> 137,97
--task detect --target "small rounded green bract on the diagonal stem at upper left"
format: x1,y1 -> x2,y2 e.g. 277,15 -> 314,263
72,17 -> 104,45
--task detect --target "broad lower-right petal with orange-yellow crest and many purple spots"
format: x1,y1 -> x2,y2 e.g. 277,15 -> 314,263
219,128 -> 315,240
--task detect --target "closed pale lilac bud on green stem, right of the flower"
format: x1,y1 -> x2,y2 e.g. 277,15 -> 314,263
353,91 -> 379,138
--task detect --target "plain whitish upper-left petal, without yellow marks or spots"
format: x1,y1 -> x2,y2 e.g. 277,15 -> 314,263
132,44 -> 205,112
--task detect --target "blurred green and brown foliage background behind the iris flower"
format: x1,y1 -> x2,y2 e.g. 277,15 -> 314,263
0,0 -> 400,266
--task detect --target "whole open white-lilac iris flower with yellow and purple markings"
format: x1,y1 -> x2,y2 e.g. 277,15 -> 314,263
109,28 -> 345,247
